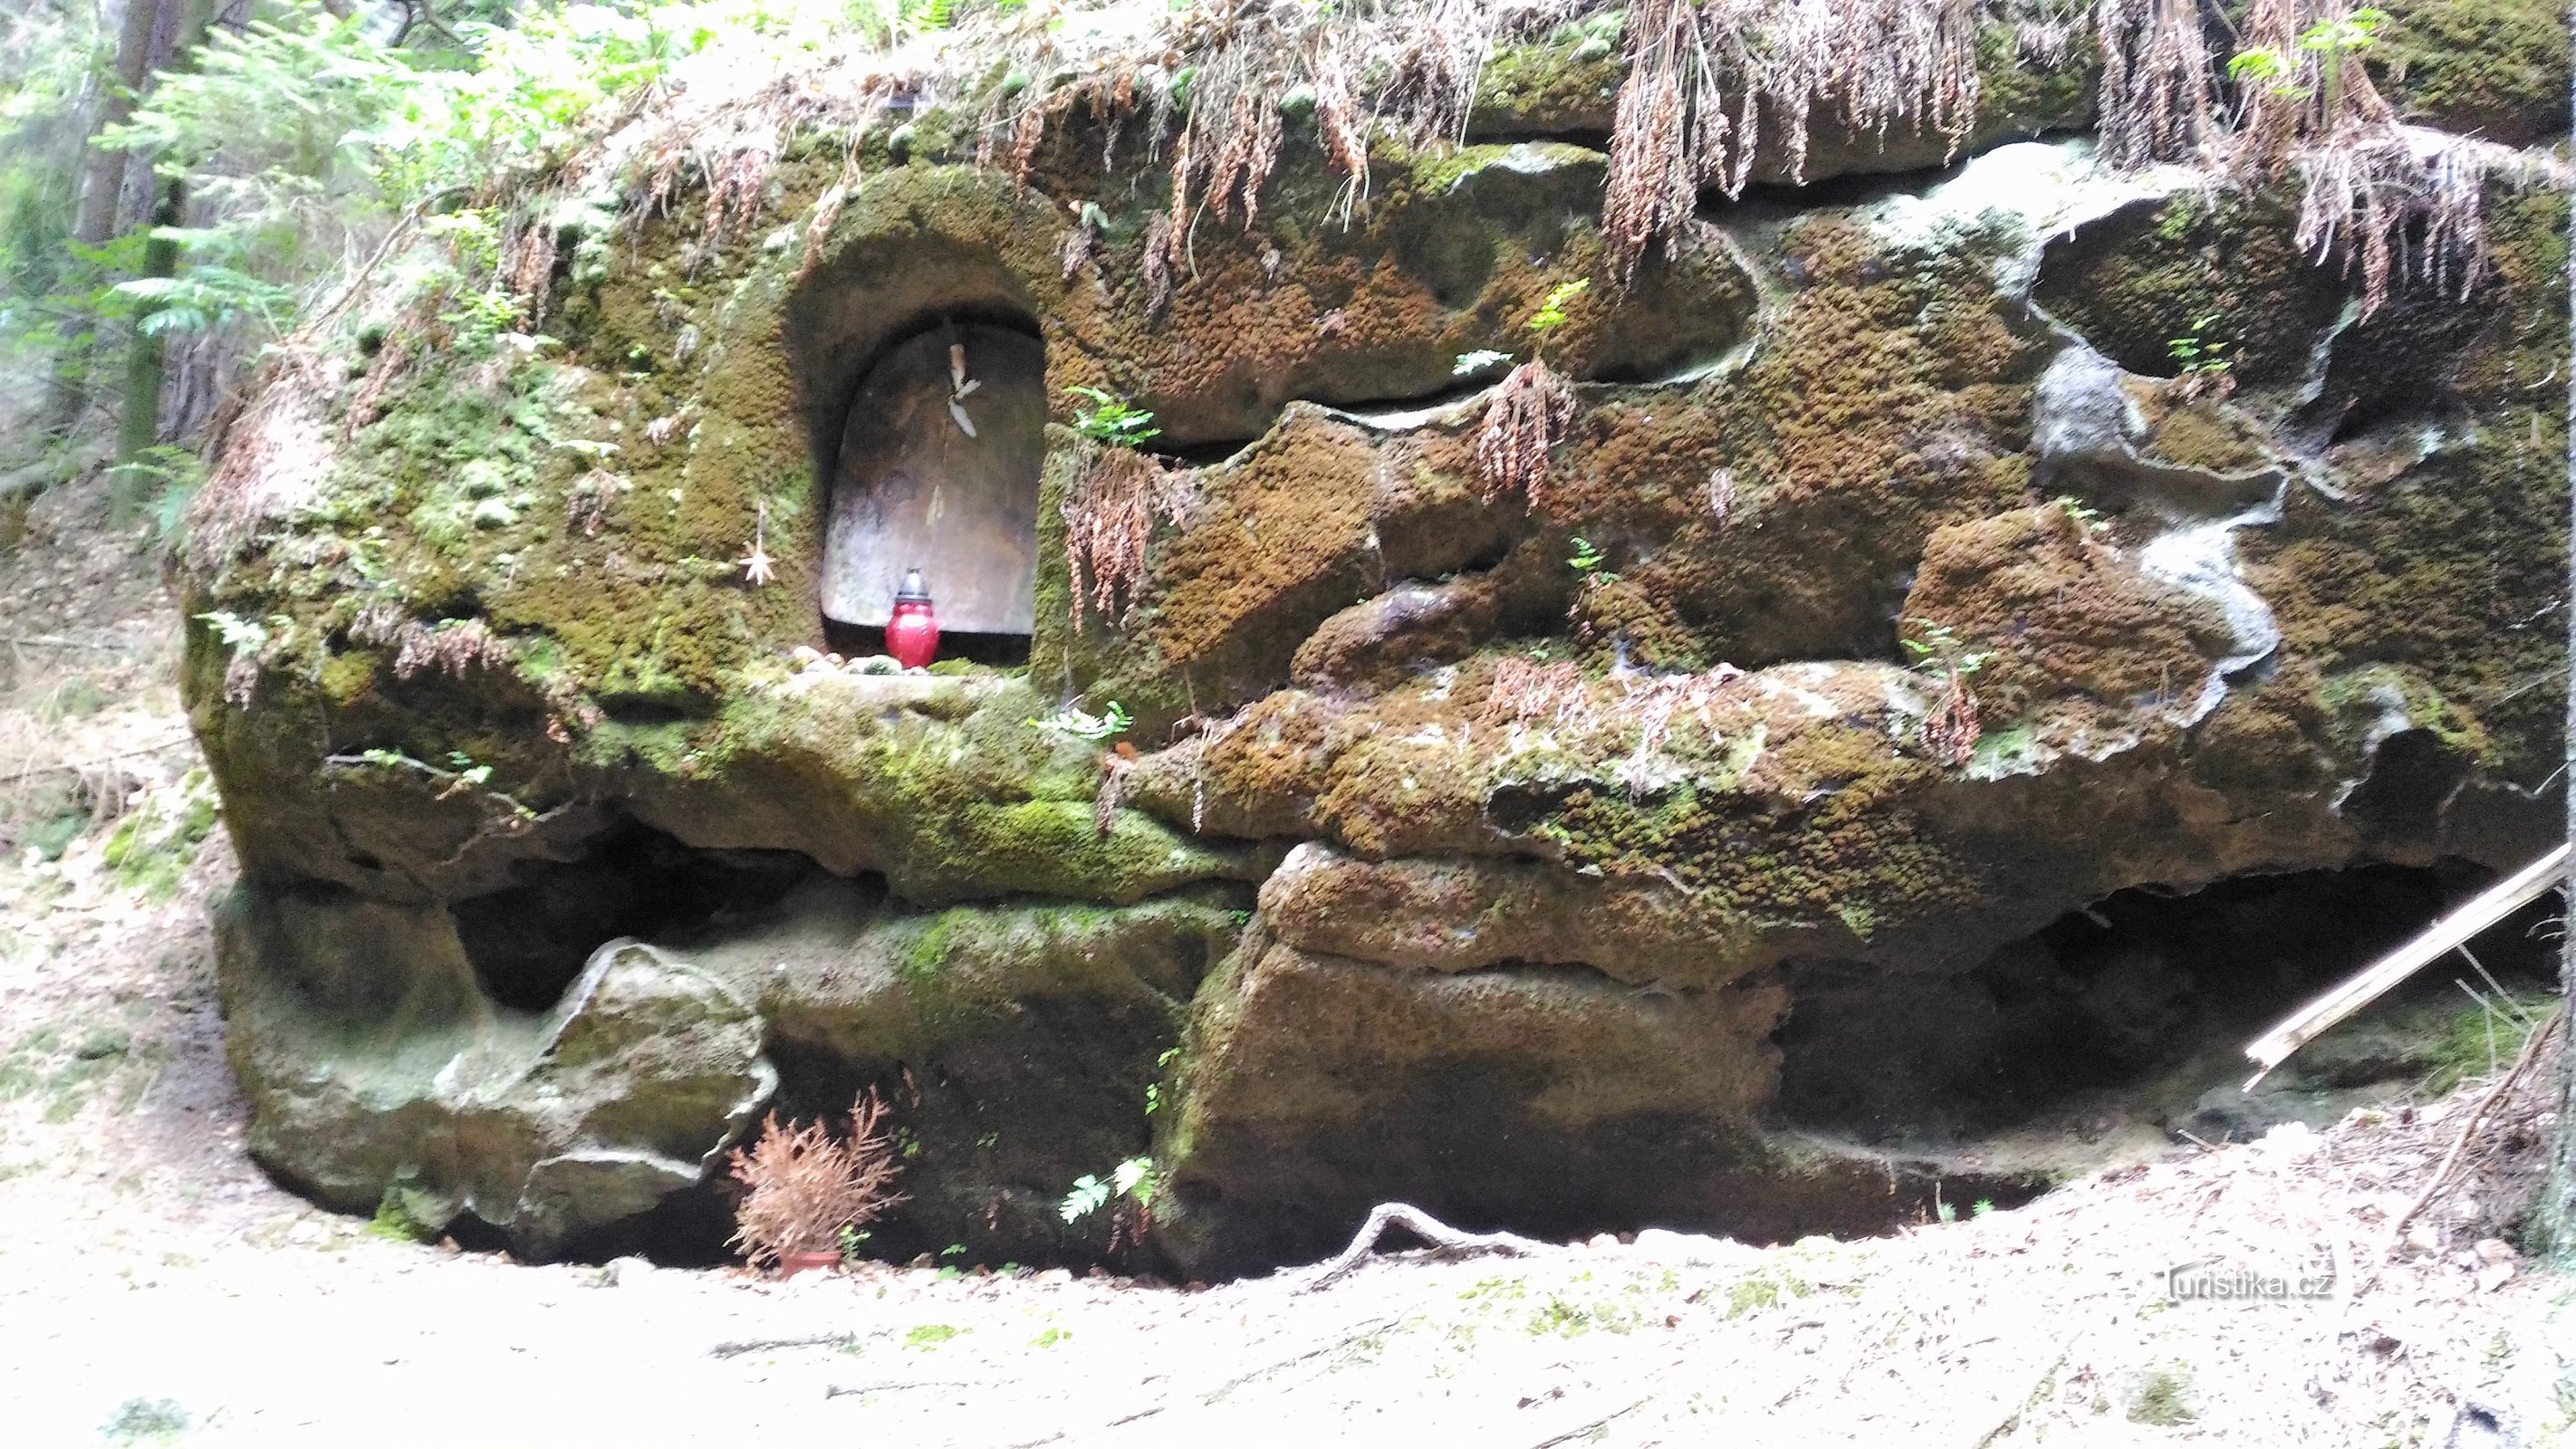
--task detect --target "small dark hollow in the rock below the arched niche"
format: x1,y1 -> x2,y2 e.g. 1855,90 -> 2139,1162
451,823 -> 819,1012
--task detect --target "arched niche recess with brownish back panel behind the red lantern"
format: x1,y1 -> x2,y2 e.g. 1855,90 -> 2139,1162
822,321 -> 1046,657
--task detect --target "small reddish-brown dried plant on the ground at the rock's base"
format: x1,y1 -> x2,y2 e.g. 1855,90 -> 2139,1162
726,1086 -> 904,1266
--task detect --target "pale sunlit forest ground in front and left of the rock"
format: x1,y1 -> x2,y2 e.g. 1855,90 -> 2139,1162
0,471 -> 2576,1449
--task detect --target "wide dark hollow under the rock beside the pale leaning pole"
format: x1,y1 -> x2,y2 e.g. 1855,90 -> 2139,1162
1775,859 -> 2558,1150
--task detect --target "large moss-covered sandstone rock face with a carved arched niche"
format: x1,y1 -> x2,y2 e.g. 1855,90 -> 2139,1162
188,5 -> 2566,1274
